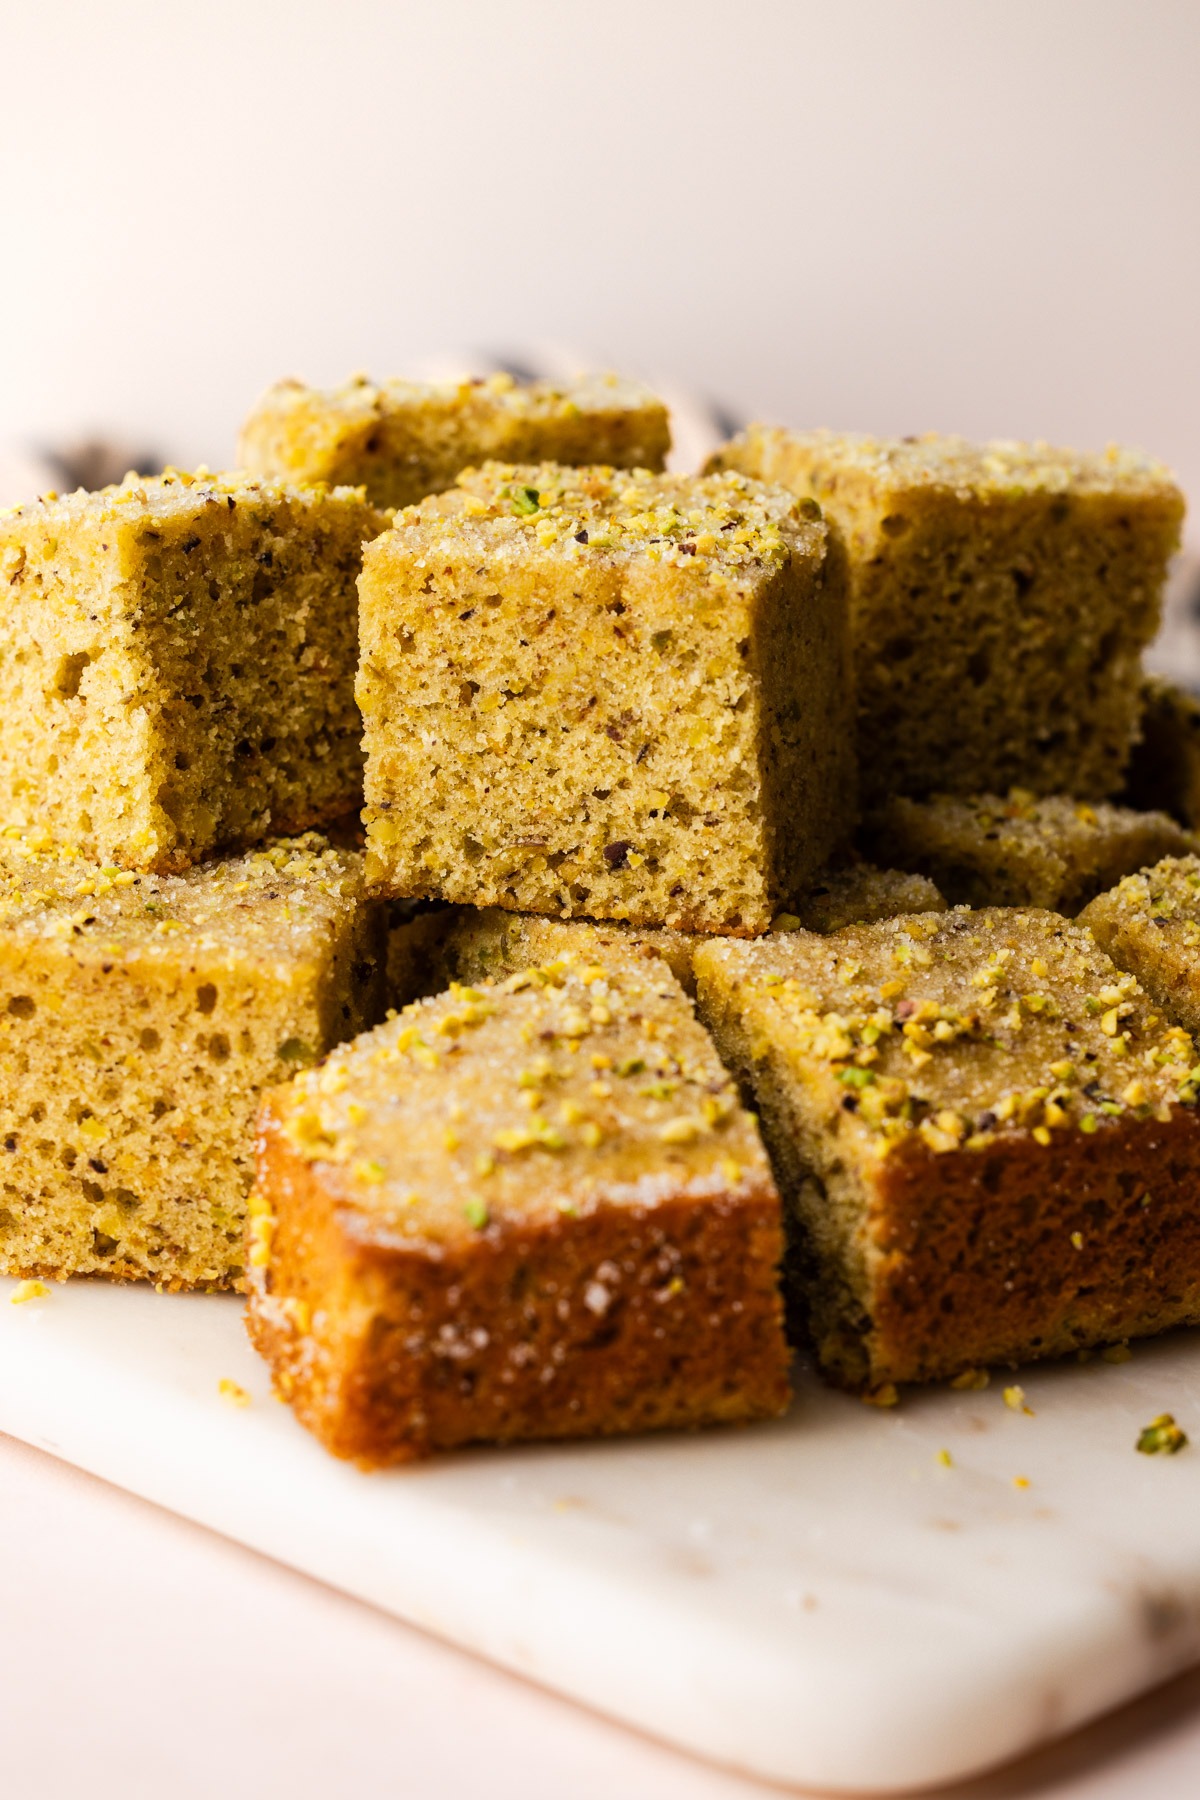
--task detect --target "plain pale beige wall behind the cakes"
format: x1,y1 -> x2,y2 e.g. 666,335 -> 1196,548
0,0 -> 1200,513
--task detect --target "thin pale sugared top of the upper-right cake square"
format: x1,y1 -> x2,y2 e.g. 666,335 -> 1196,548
716,425 -> 1177,499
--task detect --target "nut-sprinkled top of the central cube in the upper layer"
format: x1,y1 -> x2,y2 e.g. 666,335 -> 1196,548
378,463 -> 824,578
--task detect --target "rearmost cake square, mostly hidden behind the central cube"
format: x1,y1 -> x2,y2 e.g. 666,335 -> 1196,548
237,374 -> 671,506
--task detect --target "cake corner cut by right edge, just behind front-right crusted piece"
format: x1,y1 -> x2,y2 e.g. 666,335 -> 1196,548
1079,855 -> 1200,1033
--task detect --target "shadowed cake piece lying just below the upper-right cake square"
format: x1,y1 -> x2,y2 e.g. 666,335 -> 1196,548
865,788 -> 1195,914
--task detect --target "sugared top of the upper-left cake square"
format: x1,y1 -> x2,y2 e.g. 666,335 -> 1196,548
0,466 -> 376,536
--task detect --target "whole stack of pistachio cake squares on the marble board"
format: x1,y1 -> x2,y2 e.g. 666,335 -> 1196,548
0,361 -> 1200,1465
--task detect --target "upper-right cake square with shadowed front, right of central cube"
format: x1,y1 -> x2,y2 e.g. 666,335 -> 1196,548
709,425 -> 1184,803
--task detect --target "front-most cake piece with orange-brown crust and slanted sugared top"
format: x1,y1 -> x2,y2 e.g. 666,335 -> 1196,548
248,950 -> 788,1465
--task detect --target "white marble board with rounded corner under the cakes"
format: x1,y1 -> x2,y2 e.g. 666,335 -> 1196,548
0,1280 -> 1200,1793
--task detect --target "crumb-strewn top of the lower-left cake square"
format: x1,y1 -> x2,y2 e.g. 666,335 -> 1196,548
0,826 -> 363,967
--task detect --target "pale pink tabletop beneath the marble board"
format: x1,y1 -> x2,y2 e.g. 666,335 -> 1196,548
0,1435 -> 1200,1800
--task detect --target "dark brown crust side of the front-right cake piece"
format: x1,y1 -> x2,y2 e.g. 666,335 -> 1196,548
859,1109 -> 1200,1386
